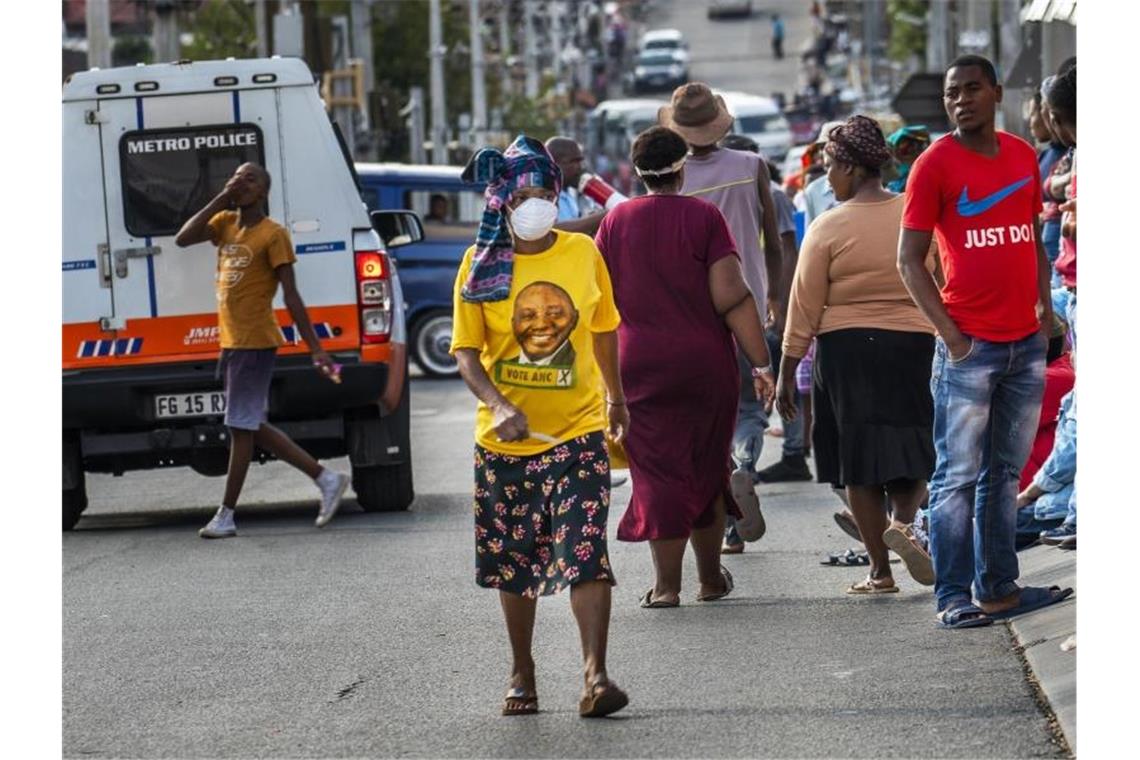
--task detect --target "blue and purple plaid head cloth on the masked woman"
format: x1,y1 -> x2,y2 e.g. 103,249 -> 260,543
461,134 -> 562,303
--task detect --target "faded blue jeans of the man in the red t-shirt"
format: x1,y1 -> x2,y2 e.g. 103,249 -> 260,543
930,332 -> 1048,611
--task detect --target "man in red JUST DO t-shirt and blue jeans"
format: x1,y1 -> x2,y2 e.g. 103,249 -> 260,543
898,56 -> 1073,628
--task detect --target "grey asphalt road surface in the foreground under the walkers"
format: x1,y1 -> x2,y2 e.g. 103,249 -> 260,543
63,379 -> 1059,758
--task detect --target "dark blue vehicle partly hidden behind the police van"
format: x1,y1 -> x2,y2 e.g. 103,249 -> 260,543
356,163 -> 483,377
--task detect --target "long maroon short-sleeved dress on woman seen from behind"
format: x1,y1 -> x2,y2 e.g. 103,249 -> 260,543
596,195 -> 741,541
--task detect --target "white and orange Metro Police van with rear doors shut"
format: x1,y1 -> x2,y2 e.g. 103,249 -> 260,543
63,58 -> 423,530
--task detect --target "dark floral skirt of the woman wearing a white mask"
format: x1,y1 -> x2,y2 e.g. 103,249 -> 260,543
474,432 -> 614,598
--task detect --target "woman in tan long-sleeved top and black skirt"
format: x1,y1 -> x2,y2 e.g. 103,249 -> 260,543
776,116 -> 934,594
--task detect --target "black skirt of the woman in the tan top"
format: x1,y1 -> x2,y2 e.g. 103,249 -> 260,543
812,328 -> 935,488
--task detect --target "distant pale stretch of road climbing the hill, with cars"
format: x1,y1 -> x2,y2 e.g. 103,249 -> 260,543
645,0 -> 811,101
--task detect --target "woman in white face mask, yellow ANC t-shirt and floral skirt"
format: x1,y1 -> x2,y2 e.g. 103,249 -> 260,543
451,134 -> 629,718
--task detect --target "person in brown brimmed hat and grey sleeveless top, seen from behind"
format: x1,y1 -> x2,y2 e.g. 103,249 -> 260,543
658,82 -> 791,553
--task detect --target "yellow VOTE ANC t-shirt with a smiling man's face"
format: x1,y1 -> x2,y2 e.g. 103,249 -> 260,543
451,230 -> 621,457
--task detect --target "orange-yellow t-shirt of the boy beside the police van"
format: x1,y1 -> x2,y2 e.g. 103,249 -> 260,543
209,211 -> 296,349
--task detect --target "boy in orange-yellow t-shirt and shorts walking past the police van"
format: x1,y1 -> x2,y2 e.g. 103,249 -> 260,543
174,163 -> 349,538
